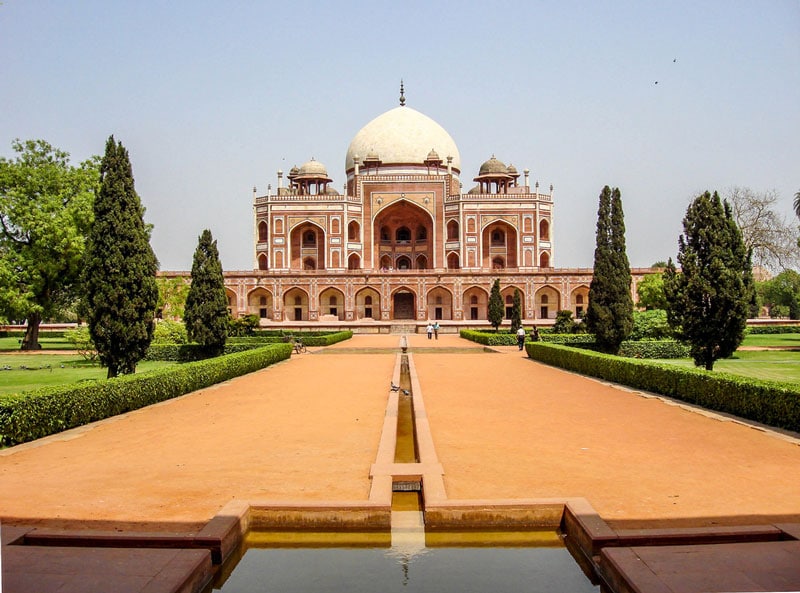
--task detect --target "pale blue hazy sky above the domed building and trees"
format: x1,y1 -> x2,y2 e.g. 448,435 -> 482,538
0,0 -> 800,270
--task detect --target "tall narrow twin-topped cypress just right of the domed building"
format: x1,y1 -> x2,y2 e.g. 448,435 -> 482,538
584,186 -> 633,354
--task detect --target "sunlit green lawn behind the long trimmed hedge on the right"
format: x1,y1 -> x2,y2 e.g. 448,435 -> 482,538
659,350 -> 800,385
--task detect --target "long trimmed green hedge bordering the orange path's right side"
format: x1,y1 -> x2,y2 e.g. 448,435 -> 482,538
526,342 -> 800,431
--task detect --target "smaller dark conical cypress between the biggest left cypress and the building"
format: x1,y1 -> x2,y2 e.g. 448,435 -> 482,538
183,229 -> 228,354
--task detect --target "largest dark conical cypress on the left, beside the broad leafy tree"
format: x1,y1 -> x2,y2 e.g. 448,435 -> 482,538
83,136 -> 158,378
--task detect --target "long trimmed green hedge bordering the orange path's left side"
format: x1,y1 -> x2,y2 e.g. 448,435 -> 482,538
0,344 -> 292,446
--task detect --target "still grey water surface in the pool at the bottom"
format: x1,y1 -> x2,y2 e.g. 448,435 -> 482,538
214,547 -> 599,593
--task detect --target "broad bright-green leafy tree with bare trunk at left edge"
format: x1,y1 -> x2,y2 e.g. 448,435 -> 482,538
0,140 -> 98,350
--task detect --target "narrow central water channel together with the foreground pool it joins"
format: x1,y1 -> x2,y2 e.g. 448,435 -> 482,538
209,342 -> 599,593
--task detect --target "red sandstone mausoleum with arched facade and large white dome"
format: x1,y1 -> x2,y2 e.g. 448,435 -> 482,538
173,86 -> 650,331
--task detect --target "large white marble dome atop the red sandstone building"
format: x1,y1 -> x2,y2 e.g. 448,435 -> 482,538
345,106 -> 461,173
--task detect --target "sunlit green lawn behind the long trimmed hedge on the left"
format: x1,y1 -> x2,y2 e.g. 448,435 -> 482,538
0,353 -> 178,396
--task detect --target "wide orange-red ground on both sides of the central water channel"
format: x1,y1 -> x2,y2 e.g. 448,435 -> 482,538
0,335 -> 800,530
